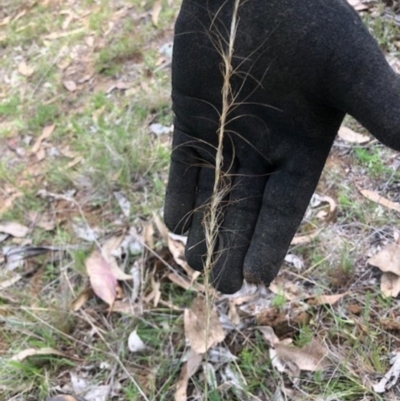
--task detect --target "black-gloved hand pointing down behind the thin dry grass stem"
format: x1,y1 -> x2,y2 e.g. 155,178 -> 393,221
165,0 -> 400,293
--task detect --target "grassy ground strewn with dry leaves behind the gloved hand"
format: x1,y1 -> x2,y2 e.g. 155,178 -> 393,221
0,0 -> 400,401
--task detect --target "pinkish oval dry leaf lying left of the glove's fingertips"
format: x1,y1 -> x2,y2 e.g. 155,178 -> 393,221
85,250 -> 117,306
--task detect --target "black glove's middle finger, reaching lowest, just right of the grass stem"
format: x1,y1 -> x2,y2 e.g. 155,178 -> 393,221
211,169 -> 268,294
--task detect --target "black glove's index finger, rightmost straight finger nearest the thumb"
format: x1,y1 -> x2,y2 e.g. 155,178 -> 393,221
243,140 -> 331,285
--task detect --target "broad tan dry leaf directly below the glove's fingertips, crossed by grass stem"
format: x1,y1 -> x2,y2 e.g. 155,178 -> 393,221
183,296 -> 225,354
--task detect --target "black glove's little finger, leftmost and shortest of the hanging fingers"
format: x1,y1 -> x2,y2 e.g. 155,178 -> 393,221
164,134 -> 200,234
